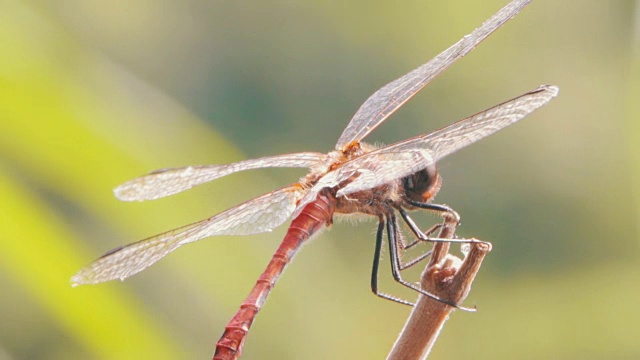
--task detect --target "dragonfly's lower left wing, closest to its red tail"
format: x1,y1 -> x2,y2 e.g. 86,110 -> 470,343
71,184 -> 305,286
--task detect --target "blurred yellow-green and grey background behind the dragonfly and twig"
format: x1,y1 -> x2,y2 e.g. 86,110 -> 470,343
0,0 -> 640,360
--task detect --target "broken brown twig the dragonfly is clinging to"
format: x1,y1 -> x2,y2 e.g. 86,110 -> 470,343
387,211 -> 491,360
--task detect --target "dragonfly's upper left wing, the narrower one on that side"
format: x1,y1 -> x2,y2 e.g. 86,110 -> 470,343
113,152 -> 325,201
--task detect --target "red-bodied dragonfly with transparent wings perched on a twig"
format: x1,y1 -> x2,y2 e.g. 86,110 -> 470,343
72,0 -> 558,360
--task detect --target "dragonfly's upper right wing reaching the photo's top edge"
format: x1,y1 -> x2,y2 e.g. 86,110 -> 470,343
336,0 -> 531,151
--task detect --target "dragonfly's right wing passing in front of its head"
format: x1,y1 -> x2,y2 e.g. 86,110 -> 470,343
330,85 -> 559,196
